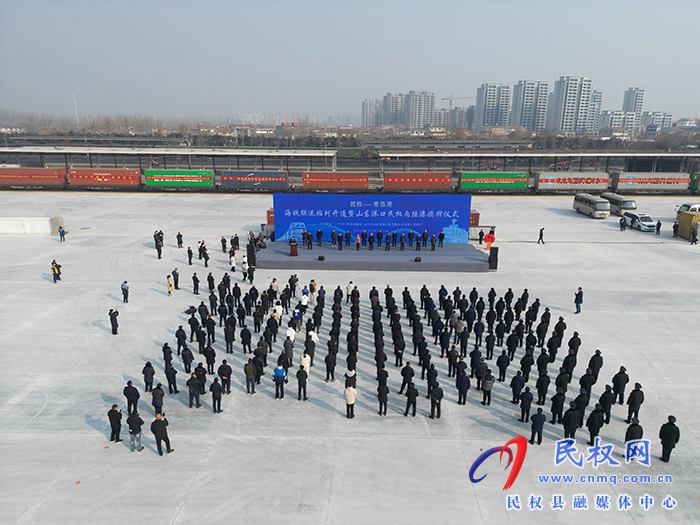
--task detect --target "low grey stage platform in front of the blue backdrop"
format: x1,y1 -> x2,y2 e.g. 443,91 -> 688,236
255,242 -> 489,272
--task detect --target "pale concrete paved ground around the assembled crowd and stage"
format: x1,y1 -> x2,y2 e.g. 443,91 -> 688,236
0,192 -> 700,524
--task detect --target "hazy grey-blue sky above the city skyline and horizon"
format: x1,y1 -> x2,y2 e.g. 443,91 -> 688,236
0,0 -> 700,118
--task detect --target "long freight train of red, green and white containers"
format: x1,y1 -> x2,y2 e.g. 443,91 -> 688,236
0,167 -> 700,195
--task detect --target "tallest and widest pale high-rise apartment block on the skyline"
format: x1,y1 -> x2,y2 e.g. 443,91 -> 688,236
547,77 -> 602,133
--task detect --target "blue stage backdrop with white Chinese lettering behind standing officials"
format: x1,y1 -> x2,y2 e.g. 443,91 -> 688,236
274,193 -> 471,244
